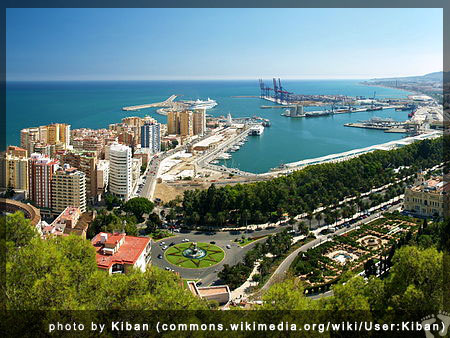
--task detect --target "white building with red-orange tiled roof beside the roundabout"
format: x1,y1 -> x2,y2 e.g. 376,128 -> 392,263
91,232 -> 151,274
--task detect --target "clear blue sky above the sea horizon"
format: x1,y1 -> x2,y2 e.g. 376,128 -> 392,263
6,8 -> 443,81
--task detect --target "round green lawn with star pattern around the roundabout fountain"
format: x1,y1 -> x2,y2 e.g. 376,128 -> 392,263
164,242 -> 225,269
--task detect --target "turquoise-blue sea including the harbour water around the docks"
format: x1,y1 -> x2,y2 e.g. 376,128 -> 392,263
6,80 -> 412,173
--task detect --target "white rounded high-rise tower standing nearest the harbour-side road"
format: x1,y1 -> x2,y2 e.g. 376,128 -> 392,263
108,144 -> 132,200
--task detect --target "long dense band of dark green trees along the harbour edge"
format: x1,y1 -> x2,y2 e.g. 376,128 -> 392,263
180,138 -> 443,227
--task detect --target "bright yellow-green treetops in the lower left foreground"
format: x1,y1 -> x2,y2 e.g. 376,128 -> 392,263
1,214 -> 209,315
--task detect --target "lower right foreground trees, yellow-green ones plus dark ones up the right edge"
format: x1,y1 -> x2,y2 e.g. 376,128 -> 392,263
262,220 -> 450,322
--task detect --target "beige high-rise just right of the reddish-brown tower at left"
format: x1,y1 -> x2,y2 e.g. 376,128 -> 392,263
52,164 -> 86,215
